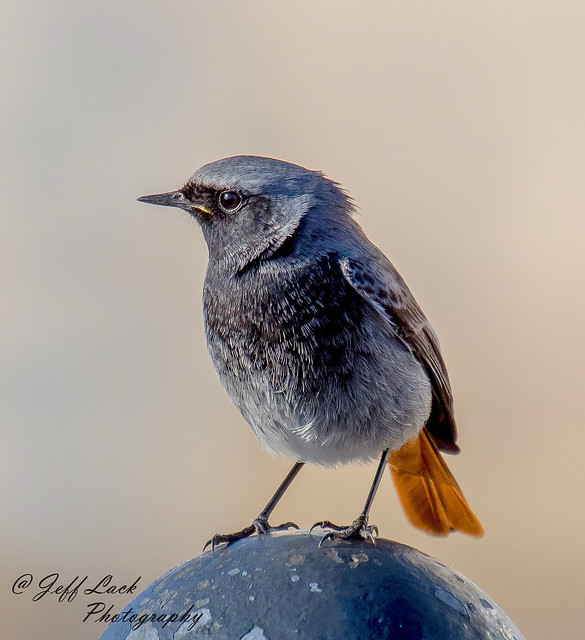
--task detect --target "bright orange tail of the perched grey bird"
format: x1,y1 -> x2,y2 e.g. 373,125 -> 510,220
389,429 -> 483,536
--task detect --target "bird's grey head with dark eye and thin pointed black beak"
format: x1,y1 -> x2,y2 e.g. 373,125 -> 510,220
138,156 -> 351,271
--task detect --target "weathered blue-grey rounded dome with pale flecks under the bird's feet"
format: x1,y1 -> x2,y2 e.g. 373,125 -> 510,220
100,532 -> 523,640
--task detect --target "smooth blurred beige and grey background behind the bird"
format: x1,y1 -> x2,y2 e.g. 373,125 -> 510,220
0,0 -> 585,640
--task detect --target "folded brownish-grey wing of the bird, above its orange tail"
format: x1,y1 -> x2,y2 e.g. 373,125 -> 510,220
340,255 -> 459,453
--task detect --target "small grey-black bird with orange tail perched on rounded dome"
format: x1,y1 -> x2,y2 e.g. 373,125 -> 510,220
138,155 -> 483,549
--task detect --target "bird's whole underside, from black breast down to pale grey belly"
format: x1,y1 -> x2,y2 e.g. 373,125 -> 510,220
204,257 -> 430,464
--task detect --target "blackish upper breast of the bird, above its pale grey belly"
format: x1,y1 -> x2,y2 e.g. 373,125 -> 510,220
204,257 -> 363,387
